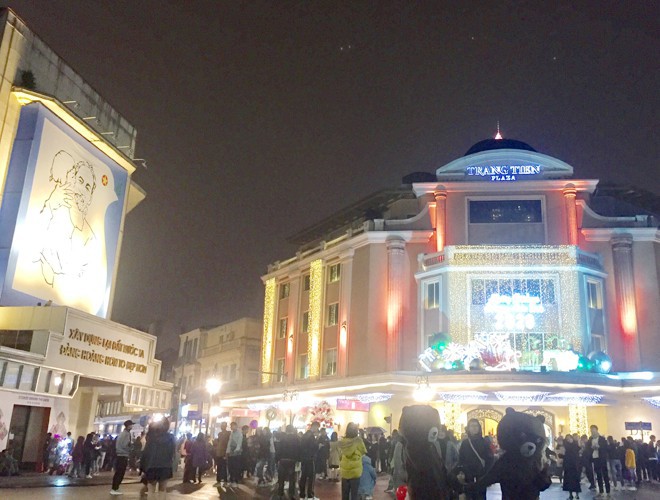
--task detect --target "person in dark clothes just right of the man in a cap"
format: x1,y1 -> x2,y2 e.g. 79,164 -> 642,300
140,418 -> 176,496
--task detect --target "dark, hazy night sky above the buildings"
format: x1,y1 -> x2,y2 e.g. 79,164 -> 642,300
10,0 -> 660,348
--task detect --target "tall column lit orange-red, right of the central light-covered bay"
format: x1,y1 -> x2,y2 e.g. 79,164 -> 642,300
611,234 -> 641,371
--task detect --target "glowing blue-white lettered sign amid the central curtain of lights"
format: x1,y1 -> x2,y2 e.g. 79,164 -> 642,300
484,293 -> 545,331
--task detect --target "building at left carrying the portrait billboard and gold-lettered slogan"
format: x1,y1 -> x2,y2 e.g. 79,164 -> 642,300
0,9 -> 172,468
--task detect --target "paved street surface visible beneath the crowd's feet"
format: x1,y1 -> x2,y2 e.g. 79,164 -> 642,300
0,473 -> 660,500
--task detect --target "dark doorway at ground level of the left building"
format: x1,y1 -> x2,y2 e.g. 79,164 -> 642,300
7,405 -> 50,471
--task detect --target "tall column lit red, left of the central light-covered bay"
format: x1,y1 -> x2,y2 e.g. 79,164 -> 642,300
387,238 -> 406,371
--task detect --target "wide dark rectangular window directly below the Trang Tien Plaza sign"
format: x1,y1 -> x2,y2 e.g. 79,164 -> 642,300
470,200 -> 543,224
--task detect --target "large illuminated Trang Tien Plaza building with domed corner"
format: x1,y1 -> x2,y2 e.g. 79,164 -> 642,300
226,134 -> 660,442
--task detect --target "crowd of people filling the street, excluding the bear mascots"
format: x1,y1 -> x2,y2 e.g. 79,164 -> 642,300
0,419 -> 660,500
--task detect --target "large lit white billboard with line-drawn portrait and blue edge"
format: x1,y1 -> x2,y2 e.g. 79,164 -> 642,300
0,103 -> 128,317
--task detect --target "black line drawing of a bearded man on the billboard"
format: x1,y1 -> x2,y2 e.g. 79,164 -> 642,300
39,150 -> 96,286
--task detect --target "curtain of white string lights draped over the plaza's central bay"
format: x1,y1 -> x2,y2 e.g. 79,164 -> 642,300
442,245 -> 586,362
